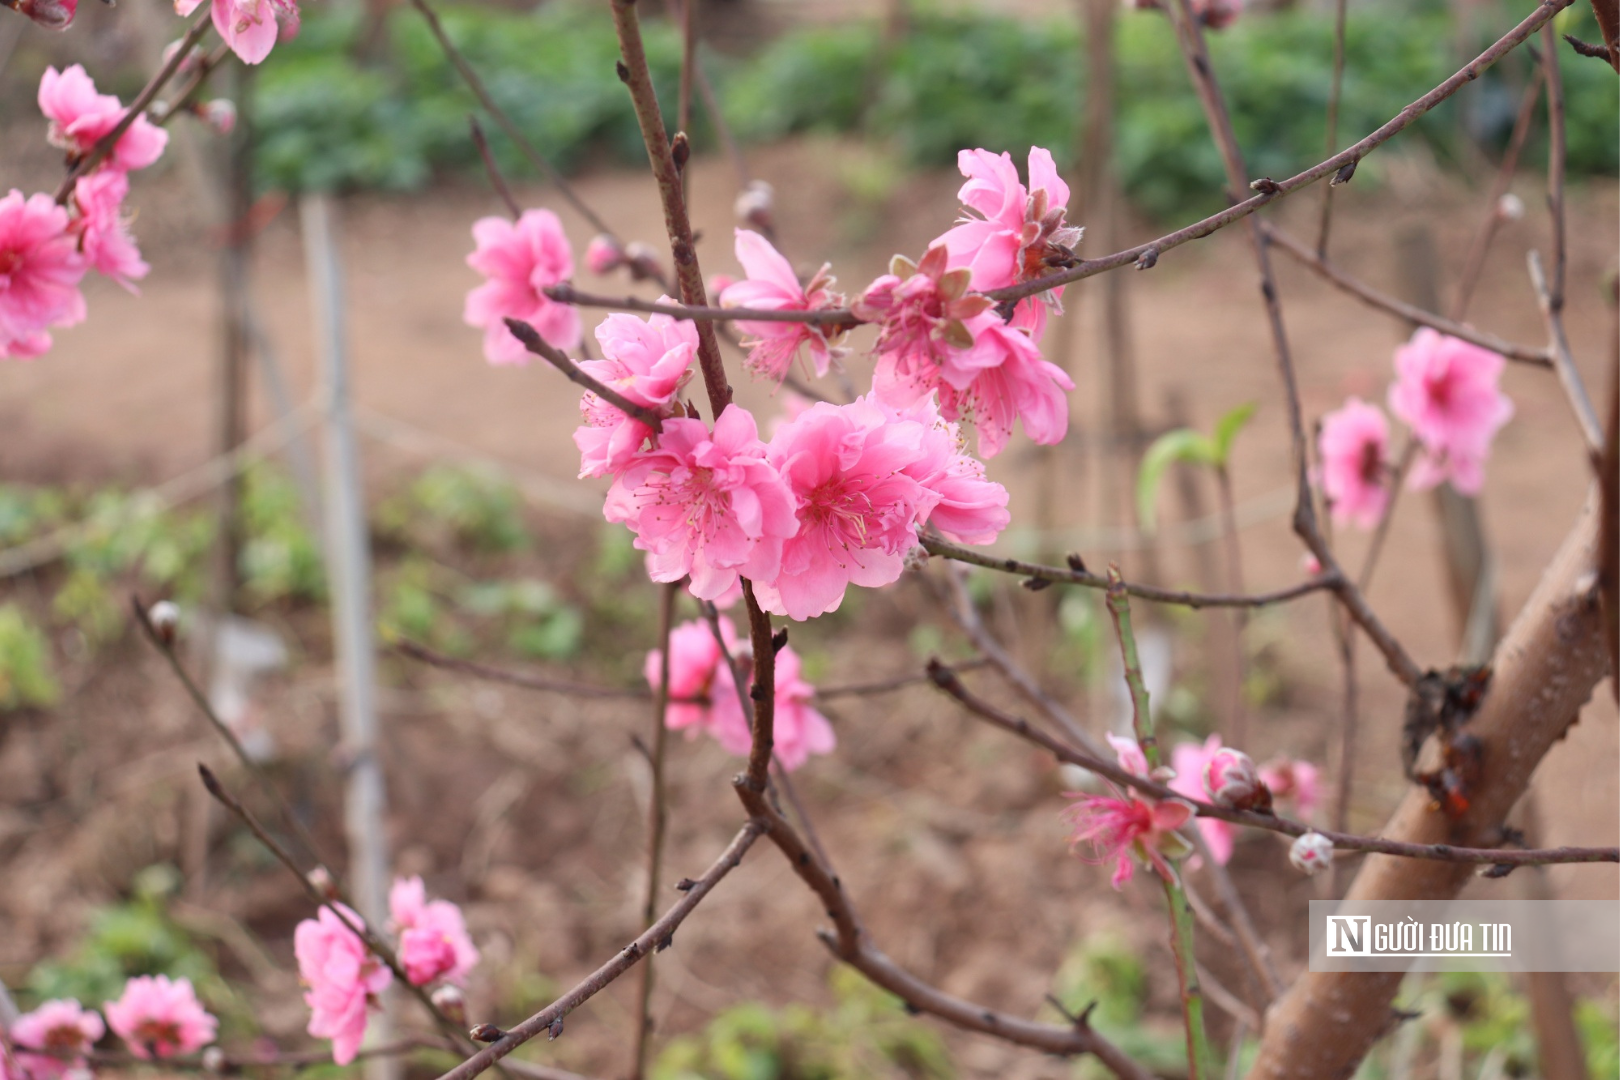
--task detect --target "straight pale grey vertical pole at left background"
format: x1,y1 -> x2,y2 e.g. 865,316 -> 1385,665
298,194 -> 399,1080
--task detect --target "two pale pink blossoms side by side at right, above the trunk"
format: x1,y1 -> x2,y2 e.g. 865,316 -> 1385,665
1317,327 -> 1513,528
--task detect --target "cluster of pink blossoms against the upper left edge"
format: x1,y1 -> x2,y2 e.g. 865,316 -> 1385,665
0,65 -> 168,359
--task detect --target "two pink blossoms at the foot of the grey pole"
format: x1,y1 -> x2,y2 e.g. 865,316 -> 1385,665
293,878 -> 478,1065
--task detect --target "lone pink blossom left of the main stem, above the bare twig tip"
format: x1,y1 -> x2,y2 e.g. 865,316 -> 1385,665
462,210 -> 580,364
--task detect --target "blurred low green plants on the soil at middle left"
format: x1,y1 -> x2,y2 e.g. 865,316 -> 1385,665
0,465 -> 592,712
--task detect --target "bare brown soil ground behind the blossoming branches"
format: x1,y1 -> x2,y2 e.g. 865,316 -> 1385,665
0,127 -> 1620,1078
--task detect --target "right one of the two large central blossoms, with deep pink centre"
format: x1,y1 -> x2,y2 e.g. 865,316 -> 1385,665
753,395 -> 940,619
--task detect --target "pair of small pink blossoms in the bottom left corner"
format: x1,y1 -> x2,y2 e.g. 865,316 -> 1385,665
0,975 -> 219,1080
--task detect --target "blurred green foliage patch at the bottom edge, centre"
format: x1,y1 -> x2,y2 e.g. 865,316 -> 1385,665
651,967 -> 954,1080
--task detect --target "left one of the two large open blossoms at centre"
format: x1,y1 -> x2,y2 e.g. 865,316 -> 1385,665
603,405 -> 799,599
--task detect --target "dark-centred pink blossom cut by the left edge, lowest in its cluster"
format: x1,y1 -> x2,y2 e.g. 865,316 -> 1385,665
0,189 -> 86,359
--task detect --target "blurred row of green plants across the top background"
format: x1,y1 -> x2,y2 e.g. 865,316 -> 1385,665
254,0 -> 1620,219
